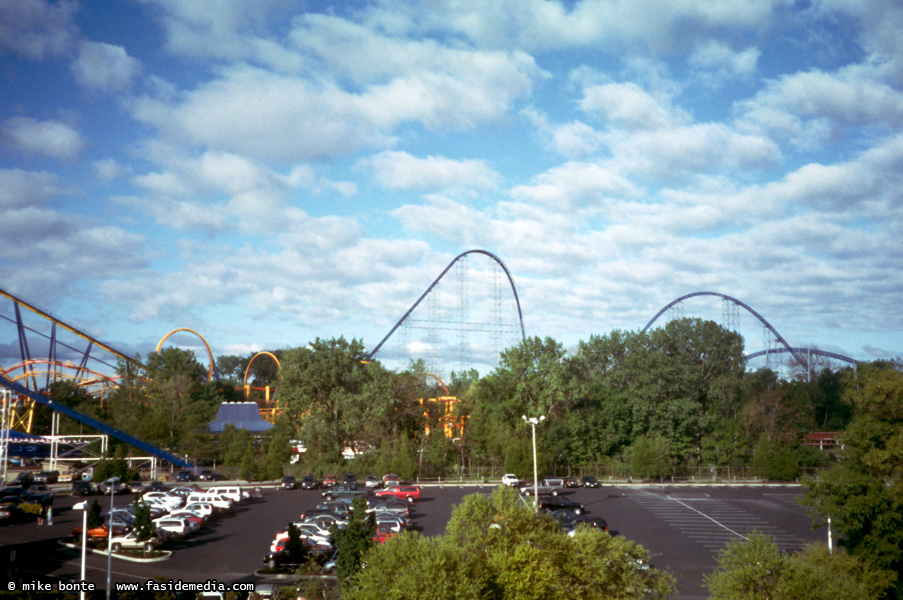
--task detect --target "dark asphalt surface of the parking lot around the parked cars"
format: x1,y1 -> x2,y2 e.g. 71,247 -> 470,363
0,485 -> 825,600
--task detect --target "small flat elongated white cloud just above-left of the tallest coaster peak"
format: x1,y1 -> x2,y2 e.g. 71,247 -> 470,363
360,150 -> 502,190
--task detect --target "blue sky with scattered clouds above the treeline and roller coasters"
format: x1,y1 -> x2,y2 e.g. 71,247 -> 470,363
0,0 -> 903,373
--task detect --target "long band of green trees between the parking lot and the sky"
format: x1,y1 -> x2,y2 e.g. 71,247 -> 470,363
39,319 -> 868,479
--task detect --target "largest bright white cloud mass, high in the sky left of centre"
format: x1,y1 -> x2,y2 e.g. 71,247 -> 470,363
131,15 -> 543,162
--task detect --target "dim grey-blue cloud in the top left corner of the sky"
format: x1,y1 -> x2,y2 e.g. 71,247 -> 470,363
0,0 -> 79,60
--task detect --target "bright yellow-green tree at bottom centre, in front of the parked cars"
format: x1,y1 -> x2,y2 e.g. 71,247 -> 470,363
343,488 -> 673,600
